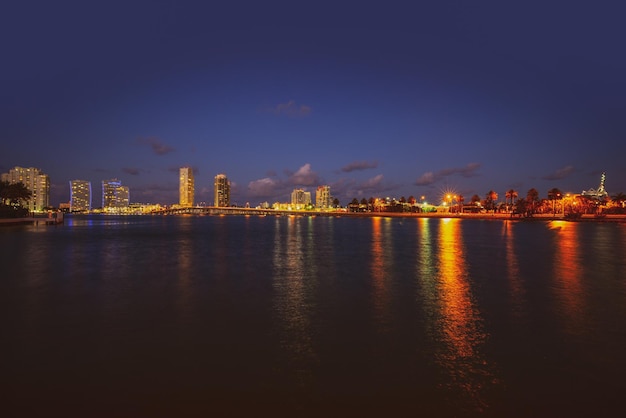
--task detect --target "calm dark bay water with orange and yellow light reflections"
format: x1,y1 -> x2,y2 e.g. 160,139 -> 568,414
0,216 -> 626,417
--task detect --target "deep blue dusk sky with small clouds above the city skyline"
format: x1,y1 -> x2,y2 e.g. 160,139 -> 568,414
0,1 -> 626,206
